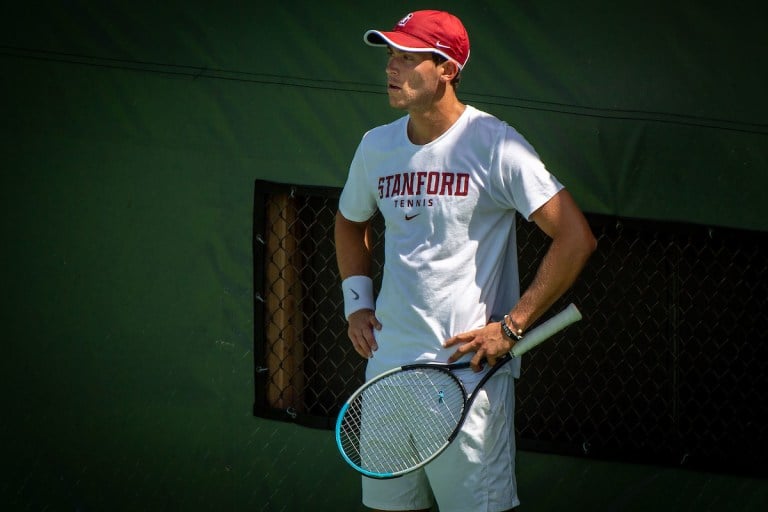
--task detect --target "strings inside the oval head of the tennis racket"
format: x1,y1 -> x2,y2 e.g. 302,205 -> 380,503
341,368 -> 466,474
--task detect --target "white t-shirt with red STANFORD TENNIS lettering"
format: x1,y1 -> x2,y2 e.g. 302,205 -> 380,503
339,106 -> 563,384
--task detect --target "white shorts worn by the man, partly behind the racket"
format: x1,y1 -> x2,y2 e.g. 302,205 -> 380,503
362,373 -> 520,512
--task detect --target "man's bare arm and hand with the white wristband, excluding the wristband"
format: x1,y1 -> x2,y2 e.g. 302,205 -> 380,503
334,212 -> 381,358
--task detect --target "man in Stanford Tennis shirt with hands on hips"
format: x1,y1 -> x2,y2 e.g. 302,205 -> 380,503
335,11 -> 596,512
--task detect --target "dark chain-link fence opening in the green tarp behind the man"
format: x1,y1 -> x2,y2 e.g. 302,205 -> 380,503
253,181 -> 768,473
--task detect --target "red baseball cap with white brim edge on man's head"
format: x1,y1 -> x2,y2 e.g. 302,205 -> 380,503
363,10 -> 469,69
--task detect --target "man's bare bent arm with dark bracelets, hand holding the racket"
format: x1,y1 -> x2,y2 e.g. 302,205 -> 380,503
445,189 -> 597,370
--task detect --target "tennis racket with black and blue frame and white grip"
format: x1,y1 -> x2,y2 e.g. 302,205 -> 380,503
336,304 -> 581,479
